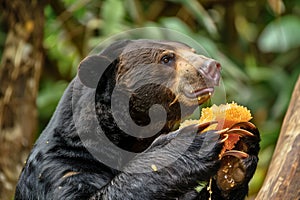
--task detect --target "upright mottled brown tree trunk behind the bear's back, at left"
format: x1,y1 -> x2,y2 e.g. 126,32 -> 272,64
0,0 -> 44,200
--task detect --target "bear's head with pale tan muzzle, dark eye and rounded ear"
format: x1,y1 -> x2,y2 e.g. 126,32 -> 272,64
78,39 -> 221,152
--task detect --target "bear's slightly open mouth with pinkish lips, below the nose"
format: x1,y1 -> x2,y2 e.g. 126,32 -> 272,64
184,87 -> 214,105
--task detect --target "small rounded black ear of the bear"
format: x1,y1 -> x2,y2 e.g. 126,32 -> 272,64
78,55 -> 112,88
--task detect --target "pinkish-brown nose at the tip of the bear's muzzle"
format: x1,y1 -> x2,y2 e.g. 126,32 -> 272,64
201,59 -> 221,85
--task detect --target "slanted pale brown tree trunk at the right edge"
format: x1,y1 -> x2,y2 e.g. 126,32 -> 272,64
256,77 -> 300,200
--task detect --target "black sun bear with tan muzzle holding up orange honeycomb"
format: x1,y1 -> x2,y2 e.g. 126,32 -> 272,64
15,39 -> 259,200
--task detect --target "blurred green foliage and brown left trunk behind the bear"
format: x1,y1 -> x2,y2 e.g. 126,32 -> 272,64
0,0 -> 300,199
